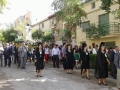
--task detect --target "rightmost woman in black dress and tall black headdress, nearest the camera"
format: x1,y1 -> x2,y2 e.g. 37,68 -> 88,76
97,43 -> 110,86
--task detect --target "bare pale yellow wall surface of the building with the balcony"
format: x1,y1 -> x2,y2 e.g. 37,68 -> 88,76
76,0 -> 120,46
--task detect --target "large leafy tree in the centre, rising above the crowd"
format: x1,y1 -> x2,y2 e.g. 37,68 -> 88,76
52,0 -> 86,43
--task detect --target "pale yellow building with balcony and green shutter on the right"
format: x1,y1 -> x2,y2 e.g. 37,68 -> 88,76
76,0 -> 120,47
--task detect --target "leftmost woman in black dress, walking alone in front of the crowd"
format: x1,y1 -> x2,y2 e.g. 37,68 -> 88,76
36,43 -> 45,77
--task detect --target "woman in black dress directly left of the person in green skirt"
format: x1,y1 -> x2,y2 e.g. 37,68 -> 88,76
64,45 -> 74,74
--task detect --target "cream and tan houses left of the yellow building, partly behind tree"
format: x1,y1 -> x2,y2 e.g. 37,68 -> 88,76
32,14 -> 64,45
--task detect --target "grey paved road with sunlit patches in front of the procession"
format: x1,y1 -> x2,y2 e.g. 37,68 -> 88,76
0,63 -> 117,90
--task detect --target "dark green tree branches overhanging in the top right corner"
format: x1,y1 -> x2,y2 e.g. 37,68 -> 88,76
101,0 -> 120,19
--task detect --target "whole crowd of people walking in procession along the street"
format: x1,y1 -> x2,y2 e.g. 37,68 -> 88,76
0,42 -> 120,90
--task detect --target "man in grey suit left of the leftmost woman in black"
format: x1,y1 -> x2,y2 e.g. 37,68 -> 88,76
18,43 -> 27,69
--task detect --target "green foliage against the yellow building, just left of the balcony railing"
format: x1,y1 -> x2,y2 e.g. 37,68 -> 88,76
86,23 -> 108,39
